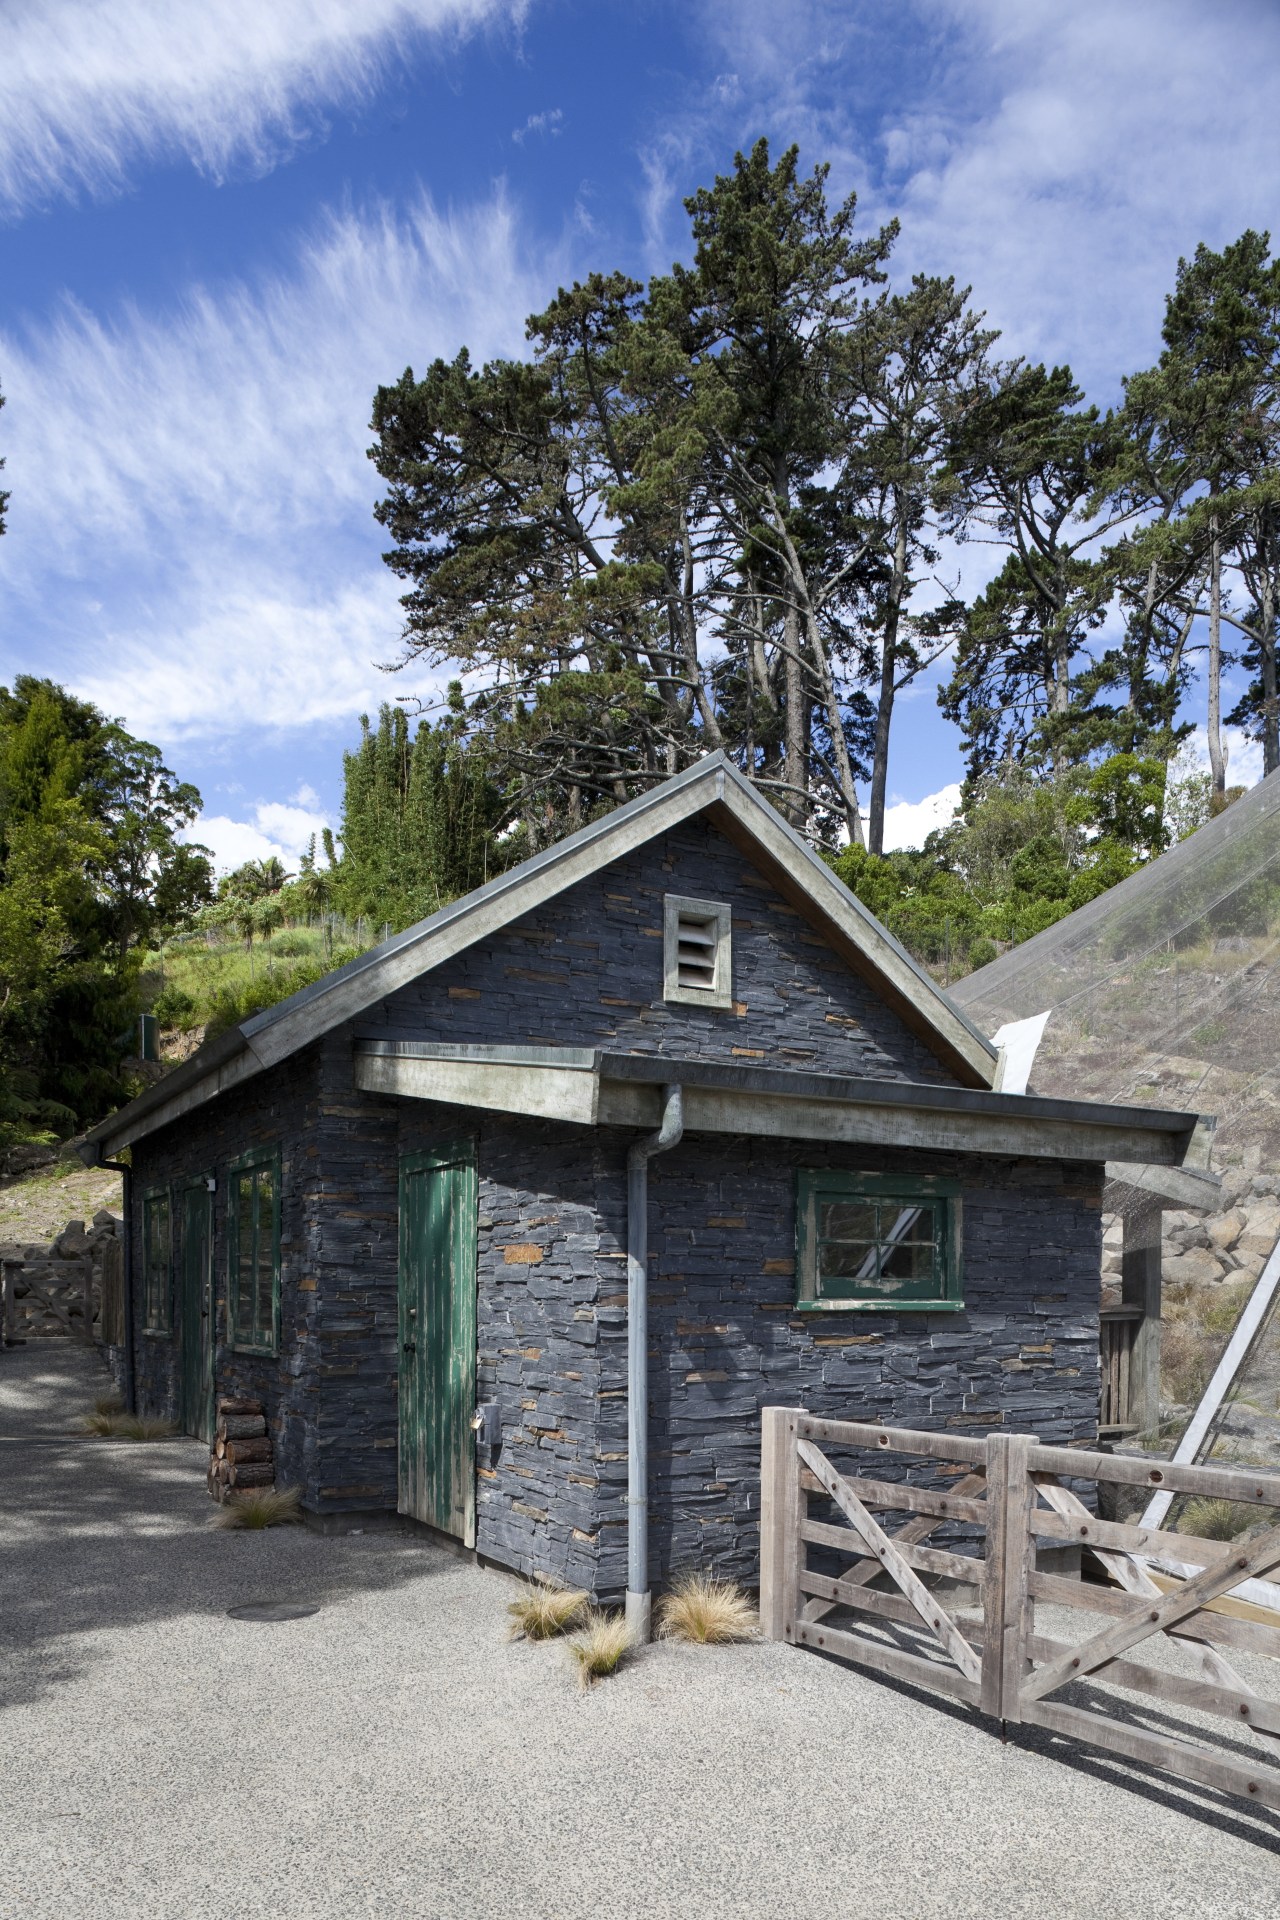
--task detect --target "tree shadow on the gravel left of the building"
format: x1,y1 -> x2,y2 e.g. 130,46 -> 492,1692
0,1342 -> 459,1707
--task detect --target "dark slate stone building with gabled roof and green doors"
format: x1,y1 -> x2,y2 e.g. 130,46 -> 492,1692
88,755 -> 1196,1619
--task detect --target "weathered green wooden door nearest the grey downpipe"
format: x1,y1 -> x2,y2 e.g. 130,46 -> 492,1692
397,1144 -> 476,1548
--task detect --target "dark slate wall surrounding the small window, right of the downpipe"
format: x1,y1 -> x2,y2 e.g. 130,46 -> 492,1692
597,1139 -> 1102,1594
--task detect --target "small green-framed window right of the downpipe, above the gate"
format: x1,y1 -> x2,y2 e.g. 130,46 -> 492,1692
796,1173 -> 963,1313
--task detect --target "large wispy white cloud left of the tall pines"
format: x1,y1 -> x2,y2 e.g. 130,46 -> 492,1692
0,192 -> 560,743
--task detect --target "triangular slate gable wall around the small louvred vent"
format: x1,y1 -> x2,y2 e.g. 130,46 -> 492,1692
359,820 -> 954,1085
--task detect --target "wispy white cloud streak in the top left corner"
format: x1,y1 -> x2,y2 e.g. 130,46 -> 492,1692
0,0 -> 522,211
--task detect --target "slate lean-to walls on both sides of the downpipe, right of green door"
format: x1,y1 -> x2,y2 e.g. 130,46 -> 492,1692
387,1102 -> 1102,1599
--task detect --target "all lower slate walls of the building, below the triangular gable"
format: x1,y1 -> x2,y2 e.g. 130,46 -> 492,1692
134,1059 -> 1102,1599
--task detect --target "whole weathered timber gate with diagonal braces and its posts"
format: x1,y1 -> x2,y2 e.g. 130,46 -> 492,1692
760,1407 -> 1280,1809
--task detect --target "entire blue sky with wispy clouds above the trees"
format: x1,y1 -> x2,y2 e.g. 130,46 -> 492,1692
0,0 -> 1280,864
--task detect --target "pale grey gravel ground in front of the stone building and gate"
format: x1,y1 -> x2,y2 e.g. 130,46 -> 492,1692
0,1342 -> 1280,1920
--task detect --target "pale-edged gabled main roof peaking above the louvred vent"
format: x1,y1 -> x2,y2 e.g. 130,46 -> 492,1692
86,753 -> 996,1154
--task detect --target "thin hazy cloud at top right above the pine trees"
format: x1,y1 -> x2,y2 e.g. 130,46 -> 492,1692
687,0 -> 1280,399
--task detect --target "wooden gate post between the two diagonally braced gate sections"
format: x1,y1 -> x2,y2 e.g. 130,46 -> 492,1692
979,1432 -> 1036,1722
